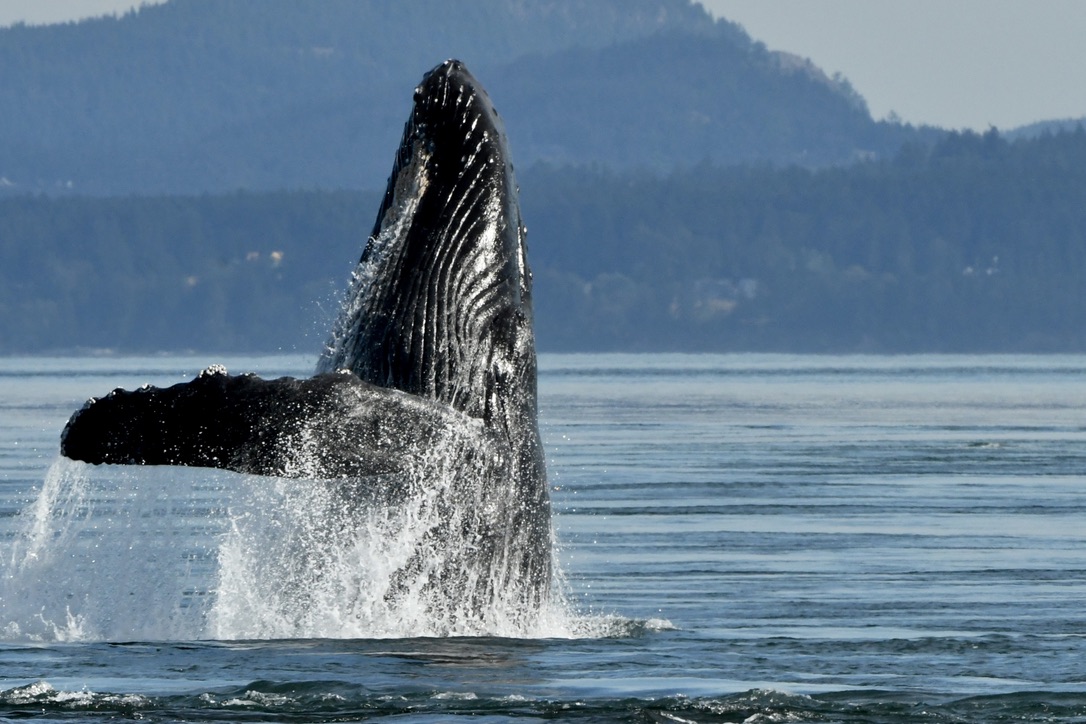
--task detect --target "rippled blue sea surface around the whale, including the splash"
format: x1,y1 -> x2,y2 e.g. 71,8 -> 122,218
0,355 -> 1086,722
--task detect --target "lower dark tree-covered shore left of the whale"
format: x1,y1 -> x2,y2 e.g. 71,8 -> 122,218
0,192 -> 378,354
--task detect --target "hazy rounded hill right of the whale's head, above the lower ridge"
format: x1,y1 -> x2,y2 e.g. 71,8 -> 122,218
490,32 -> 920,170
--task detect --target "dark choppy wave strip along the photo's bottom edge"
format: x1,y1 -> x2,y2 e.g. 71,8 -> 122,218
8,681 -> 1086,724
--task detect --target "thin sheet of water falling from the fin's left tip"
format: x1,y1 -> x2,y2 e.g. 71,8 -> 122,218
0,458 -> 223,640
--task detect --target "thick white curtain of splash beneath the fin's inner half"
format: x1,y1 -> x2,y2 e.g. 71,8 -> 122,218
209,466 -> 557,638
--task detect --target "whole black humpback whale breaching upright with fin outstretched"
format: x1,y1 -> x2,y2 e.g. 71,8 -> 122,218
61,61 -> 552,606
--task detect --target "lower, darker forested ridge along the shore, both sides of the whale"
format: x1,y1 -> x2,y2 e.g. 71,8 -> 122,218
0,128 -> 1086,354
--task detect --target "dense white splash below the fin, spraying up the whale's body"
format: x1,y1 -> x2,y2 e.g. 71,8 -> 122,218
209,410 -> 568,638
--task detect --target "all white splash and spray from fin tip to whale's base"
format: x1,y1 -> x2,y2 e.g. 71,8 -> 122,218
0,453 -> 632,642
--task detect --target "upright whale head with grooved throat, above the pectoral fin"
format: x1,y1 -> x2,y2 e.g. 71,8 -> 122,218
318,61 -> 535,434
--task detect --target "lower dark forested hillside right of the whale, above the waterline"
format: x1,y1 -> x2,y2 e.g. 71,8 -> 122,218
529,127 -> 1086,352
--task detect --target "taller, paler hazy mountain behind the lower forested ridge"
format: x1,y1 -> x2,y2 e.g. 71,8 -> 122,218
0,0 -> 937,195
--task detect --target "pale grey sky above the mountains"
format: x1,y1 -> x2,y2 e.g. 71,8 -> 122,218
0,0 -> 1086,130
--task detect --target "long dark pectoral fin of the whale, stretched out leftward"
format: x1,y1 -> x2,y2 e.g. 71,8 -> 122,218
61,371 -> 480,478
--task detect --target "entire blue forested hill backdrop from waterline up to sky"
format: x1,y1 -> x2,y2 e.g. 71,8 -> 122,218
0,0 -> 1086,354
